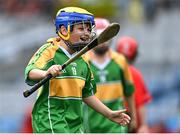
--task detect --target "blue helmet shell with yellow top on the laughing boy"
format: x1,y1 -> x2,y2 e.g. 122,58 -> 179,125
55,7 -> 95,40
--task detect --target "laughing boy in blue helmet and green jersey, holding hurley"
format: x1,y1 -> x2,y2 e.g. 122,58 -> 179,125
25,7 -> 130,133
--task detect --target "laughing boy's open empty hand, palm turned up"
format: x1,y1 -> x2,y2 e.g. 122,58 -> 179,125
109,109 -> 131,126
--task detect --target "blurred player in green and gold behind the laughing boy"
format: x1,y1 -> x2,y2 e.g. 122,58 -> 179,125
84,18 -> 136,133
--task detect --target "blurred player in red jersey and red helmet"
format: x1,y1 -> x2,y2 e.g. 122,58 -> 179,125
116,36 -> 152,133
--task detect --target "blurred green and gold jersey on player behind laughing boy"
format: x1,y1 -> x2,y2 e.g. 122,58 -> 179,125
84,51 -> 134,133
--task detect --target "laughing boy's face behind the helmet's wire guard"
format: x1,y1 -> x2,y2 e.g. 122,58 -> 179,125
69,23 -> 91,44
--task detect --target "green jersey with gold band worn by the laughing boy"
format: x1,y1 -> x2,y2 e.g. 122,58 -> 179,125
25,38 -> 96,133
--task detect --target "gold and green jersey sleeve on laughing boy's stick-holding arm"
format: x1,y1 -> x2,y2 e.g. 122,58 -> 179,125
25,43 -> 52,86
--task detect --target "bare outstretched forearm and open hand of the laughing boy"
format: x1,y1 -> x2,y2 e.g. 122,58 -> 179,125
83,95 -> 130,126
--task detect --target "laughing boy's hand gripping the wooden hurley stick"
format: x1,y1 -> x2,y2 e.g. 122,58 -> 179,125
45,65 -> 62,77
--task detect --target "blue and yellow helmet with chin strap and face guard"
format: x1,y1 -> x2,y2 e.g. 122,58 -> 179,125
55,7 -> 95,51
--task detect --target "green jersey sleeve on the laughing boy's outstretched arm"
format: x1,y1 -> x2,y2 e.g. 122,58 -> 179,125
82,62 -> 96,98
